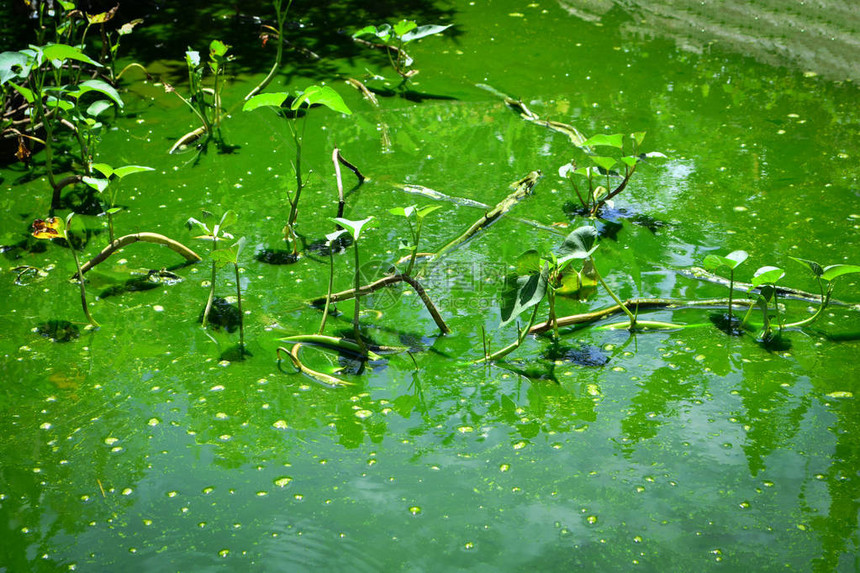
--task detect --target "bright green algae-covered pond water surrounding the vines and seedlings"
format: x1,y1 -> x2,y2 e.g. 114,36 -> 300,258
0,0 -> 860,572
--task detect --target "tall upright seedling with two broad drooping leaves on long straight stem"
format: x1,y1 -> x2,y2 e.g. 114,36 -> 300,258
242,86 -> 352,257
